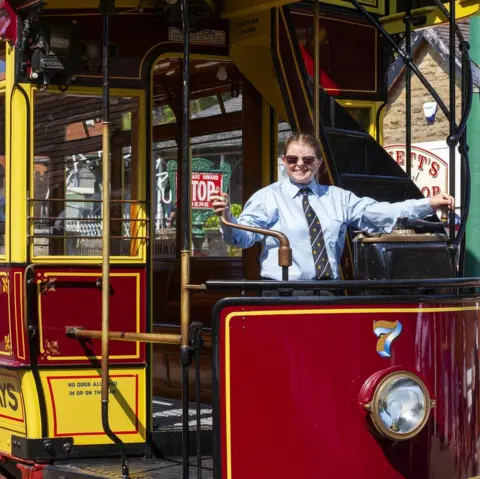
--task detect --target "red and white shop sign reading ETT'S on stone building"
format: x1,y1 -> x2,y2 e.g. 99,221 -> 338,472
385,145 -> 448,198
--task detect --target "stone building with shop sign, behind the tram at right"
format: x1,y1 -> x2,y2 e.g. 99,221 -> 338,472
383,20 -> 480,207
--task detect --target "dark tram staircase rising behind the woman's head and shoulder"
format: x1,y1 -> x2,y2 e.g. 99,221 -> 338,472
273,8 -> 423,202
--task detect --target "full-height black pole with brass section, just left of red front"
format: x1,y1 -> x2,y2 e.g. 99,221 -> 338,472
180,0 -> 191,479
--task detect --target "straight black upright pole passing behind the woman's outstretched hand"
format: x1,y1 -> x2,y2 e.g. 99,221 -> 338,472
447,0 -> 457,245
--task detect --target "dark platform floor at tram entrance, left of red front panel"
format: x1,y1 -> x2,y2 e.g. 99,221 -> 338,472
44,398 -> 213,479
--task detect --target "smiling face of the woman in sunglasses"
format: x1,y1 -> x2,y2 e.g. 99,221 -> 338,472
282,143 -> 321,185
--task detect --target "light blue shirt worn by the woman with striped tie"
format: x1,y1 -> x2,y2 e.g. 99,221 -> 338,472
222,178 -> 433,280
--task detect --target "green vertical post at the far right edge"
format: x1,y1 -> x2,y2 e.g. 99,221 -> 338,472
465,16 -> 480,276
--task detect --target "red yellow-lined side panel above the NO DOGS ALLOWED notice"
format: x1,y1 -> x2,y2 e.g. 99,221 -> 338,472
35,267 -> 146,365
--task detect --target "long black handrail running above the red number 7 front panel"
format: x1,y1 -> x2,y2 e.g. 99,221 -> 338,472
205,278 -> 480,290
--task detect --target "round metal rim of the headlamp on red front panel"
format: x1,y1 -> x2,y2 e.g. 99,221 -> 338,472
364,371 -> 435,441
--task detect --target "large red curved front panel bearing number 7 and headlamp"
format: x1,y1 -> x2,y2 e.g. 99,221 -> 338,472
219,301 -> 480,479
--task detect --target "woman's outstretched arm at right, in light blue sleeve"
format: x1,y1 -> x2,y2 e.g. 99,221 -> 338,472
343,191 -> 455,233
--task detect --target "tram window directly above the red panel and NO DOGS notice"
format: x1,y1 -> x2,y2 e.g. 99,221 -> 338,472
30,92 -> 140,257
